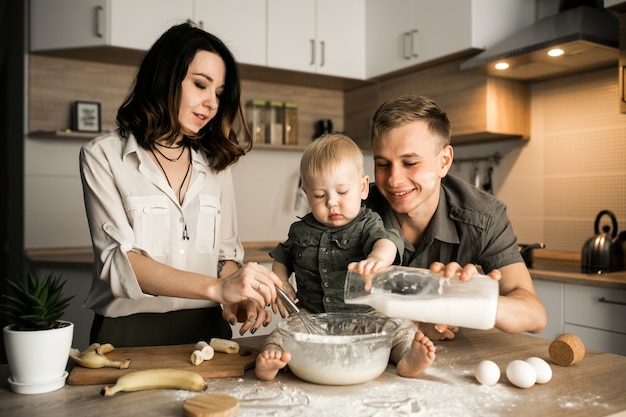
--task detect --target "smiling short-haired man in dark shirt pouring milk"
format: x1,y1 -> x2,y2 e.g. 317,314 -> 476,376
366,95 -> 547,340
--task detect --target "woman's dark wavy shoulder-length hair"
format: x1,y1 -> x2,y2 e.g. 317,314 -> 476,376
116,23 -> 252,171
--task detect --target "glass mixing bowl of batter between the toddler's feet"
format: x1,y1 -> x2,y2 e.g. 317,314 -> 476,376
277,313 -> 398,385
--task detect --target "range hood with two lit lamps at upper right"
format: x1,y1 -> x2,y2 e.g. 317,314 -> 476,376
461,2 -> 619,81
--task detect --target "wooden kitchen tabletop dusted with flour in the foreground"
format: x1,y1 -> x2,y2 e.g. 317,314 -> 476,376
0,329 -> 626,417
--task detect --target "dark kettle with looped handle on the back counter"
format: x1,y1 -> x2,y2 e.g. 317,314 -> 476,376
581,210 -> 626,274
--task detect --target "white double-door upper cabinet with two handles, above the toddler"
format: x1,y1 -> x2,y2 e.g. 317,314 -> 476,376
267,0 -> 365,79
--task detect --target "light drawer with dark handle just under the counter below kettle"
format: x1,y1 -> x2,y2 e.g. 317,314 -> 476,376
563,284 -> 626,334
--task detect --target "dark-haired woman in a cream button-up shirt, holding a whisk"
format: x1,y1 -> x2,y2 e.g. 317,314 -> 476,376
80,24 -> 281,346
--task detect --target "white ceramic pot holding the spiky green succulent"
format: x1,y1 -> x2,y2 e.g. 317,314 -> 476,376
2,321 -> 74,393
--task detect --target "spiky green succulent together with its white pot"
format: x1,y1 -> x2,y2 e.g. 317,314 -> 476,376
2,272 -> 74,394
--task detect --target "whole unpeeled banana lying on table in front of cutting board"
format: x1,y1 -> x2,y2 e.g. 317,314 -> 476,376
100,368 -> 207,397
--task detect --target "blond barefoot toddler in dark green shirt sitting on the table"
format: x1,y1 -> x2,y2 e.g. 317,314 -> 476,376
255,133 -> 435,381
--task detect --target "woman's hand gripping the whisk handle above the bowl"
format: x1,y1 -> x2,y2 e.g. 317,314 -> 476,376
215,262 -> 282,309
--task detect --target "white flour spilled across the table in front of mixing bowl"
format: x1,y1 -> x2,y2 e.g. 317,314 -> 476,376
174,346 -> 611,417
